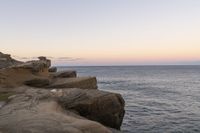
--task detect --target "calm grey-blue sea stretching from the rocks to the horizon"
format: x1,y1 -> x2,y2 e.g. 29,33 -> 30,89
59,66 -> 200,133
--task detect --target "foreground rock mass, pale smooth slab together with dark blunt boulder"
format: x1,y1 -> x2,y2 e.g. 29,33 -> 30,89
0,86 -> 124,133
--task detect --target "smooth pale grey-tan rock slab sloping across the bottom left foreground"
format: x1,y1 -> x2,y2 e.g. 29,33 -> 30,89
0,88 -> 119,133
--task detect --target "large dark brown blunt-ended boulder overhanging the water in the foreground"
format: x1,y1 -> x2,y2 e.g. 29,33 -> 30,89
57,89 -> 125,129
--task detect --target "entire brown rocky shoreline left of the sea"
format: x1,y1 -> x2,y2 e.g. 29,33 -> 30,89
0,53 -> 125,133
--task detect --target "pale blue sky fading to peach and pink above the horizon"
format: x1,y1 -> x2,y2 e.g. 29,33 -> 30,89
0,0 -> 200,66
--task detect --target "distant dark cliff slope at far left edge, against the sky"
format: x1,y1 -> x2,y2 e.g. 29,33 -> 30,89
0,52 -> 22,69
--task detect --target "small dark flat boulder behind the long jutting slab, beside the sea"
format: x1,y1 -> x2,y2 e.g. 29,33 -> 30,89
51,71 -> 77,78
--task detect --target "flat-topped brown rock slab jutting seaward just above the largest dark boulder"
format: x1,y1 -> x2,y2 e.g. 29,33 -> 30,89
46,77 -> 97,89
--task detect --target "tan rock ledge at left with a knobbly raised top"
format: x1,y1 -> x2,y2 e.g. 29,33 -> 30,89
0,60 -> 49,87
